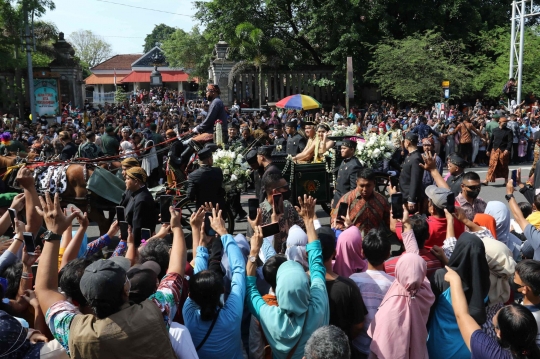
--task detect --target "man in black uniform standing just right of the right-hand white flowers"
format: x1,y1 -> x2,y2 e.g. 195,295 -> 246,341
399,132 -> 424,213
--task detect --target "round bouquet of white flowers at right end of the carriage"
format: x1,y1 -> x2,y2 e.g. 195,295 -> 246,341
356,132 -> 396,168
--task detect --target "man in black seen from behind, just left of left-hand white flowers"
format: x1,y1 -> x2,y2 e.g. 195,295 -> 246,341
187,147 -> 225,208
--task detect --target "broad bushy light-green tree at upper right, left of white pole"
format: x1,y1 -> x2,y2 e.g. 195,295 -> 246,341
367,31 -> 472,105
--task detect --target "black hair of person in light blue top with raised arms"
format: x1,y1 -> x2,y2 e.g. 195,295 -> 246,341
189,270 -> 224,321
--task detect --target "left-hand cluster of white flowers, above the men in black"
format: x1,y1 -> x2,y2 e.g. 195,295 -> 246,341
213,148 -> 251,194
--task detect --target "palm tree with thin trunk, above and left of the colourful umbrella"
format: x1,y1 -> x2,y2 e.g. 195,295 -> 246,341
229,22 -> 284,108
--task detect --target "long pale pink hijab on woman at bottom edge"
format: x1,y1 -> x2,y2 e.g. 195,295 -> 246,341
368,253 -> 435,359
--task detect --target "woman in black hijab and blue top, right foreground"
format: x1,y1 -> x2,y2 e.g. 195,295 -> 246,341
427,232 -> 490,359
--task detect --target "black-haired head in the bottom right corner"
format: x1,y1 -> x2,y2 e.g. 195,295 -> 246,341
497,304 -> 540,359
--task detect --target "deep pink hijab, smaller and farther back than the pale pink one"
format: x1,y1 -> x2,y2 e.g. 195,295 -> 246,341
333,226 -> 367,278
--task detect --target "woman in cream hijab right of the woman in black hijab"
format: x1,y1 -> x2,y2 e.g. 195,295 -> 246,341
482,238 -> 516,338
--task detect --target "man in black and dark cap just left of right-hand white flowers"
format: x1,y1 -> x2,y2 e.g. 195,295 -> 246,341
332,139 -> 362,208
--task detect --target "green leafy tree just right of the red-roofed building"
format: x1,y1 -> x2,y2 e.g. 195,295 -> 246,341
161,26 -> 213,84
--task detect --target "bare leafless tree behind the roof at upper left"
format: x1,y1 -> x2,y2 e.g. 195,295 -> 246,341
68,30 -> 112,68
